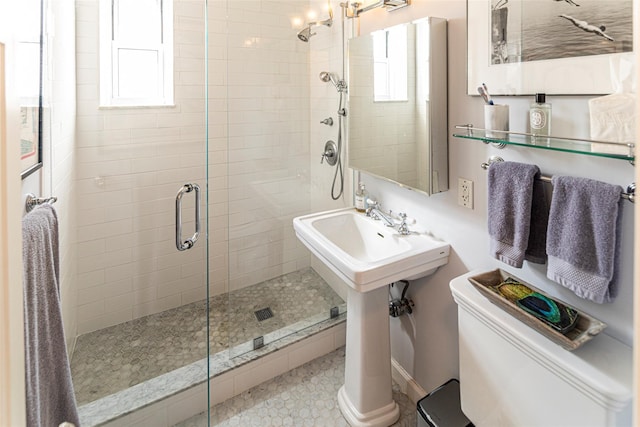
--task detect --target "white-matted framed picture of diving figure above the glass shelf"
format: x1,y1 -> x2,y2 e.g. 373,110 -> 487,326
467,0 -> 635,95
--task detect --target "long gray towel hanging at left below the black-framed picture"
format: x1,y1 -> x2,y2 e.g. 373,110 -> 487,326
22,205 -> 80,427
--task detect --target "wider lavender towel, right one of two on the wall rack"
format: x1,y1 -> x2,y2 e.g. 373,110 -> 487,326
547,176 -> 622,304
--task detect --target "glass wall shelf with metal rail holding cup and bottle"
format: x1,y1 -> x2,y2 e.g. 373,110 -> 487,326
453,125 -> 635,164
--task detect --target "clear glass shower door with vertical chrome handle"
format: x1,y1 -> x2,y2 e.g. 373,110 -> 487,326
69,0 -> 209,422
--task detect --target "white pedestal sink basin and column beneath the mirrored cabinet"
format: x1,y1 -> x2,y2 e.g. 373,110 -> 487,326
293,208 -> 449,427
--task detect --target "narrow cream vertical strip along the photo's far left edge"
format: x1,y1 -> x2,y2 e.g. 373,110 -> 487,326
0,0 -> 26,425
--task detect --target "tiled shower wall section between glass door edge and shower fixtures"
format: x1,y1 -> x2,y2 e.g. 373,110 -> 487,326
222,0 -> 320,290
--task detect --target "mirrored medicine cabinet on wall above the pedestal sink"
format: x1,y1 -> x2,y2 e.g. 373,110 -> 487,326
348,17 -> 449,194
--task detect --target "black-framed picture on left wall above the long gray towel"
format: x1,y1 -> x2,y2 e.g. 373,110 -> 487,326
16,0 -> 43,179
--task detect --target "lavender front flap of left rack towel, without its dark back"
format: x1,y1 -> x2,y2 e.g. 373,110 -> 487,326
488,162 -> 544,268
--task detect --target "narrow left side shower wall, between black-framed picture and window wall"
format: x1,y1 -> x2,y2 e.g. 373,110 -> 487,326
42,2 -> 77,351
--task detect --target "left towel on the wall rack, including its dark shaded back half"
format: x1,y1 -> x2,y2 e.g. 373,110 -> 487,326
487,162 -> 548,268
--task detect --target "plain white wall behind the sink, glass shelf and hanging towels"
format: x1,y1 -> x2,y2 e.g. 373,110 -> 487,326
328,0 -> 634,396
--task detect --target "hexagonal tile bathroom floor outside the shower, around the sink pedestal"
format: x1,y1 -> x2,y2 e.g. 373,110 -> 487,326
176,348 -> 416,427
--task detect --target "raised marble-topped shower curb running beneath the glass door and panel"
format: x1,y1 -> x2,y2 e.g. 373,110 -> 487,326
78,313 -> 346,427
